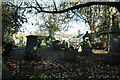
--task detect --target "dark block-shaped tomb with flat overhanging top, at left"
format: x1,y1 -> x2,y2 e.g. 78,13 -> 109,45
25,35 -> 38,60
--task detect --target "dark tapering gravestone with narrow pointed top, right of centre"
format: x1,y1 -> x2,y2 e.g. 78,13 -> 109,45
81,31 -> 92,55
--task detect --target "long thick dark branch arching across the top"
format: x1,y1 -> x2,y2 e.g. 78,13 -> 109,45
7,1 -> 120,13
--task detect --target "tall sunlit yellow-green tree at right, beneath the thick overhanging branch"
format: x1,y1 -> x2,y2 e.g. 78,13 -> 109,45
68,5 -> 117,48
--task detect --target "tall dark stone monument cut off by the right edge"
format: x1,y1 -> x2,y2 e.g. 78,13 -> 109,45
107,13 -> 120,64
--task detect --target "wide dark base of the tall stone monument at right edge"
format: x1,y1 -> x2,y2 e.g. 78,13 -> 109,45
107,53 -> 120,64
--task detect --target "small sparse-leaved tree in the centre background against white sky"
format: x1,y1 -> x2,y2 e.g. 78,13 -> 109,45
37,13 -> 70,37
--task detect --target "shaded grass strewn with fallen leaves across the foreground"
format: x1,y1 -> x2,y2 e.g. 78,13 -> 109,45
3,47 -> 120,80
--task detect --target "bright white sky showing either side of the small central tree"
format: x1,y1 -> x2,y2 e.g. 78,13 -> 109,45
21,19 -> 90,35
